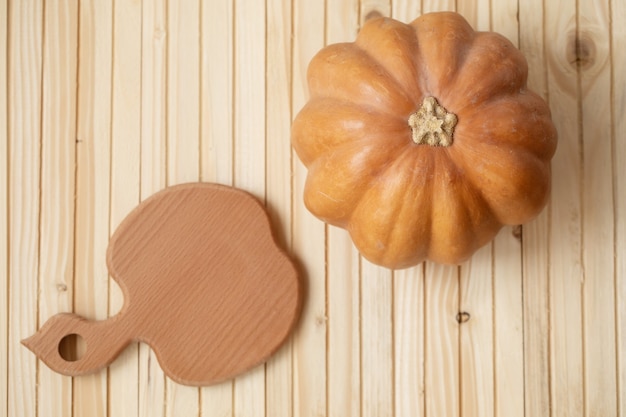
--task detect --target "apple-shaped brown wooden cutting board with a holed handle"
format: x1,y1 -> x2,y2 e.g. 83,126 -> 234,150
23,183 -> 302,385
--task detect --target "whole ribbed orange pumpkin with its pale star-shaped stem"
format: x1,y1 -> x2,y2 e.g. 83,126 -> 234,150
292,12 -> 557,268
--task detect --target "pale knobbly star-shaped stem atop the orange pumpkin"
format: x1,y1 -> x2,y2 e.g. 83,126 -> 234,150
409,97 -> 457,146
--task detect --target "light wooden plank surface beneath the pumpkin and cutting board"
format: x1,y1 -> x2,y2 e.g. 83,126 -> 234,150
0,0 -> 626,417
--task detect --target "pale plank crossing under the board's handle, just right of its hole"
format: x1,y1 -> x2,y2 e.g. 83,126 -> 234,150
73,1 -> 113,417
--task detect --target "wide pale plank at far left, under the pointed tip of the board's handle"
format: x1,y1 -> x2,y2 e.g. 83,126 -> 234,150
5,3 -> 42,417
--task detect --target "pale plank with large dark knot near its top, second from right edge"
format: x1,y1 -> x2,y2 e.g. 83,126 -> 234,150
577,1 -> 617,415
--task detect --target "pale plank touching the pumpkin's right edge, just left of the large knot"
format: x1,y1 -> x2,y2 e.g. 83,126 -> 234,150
545,0 -> 584,417
